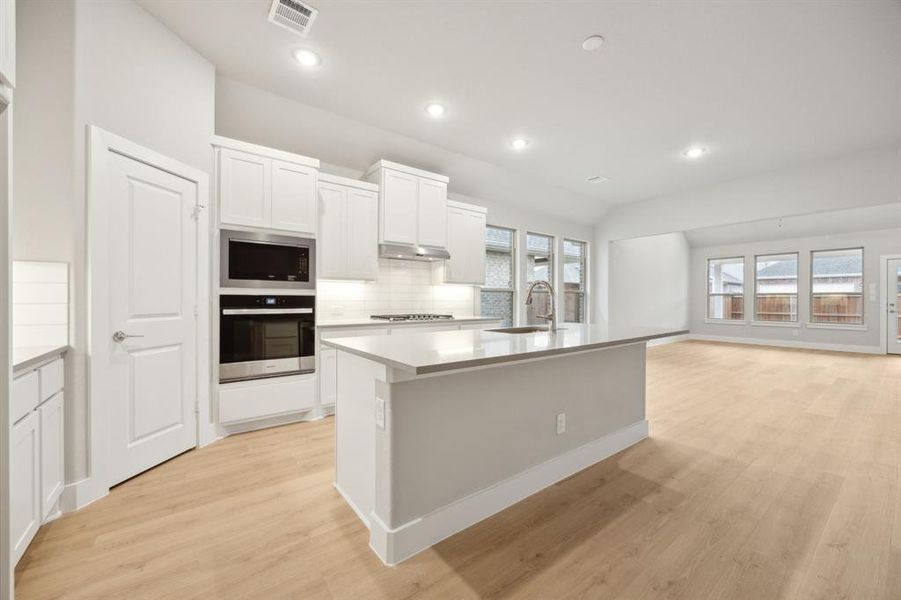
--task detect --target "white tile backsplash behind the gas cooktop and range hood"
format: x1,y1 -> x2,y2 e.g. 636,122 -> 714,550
316,259 -> 476,319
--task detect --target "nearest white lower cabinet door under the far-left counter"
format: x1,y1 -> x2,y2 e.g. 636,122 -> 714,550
9,412 -> 41,562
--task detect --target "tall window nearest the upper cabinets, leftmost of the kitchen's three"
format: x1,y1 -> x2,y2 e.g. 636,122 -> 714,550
480,225 -> 516,327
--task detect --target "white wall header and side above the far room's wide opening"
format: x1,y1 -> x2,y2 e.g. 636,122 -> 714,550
592,147 -> 901,330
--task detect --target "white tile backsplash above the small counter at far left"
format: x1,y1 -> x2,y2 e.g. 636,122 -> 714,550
12,261 -> 69,347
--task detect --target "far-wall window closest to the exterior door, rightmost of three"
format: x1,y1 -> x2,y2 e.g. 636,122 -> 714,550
810,248 -> 863,325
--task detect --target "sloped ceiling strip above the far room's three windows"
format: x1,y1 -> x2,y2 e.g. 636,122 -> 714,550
685,202 -> 901,247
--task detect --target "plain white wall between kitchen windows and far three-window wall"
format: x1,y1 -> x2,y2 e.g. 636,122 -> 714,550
610,233 -> 691,329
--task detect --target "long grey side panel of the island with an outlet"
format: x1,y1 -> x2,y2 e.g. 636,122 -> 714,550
386,343 -> 646,528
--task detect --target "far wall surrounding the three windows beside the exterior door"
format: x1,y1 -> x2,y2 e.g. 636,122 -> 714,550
690,229 -> 901,351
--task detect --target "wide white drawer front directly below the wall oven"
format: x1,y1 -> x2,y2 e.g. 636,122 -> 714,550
219,373 -> 316,423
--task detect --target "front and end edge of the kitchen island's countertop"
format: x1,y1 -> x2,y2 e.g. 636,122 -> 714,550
322,329 -> 689,375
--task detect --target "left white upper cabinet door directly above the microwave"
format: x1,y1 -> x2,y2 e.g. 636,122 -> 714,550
219,148 -> 272,227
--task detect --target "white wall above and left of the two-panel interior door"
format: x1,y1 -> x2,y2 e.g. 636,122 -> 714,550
14,0 -> 215,481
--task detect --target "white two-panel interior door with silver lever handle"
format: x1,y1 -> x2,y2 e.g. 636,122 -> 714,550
105,152 -> 198,485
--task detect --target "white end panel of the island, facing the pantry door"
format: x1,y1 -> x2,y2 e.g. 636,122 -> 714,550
335,350 -> 386,527
